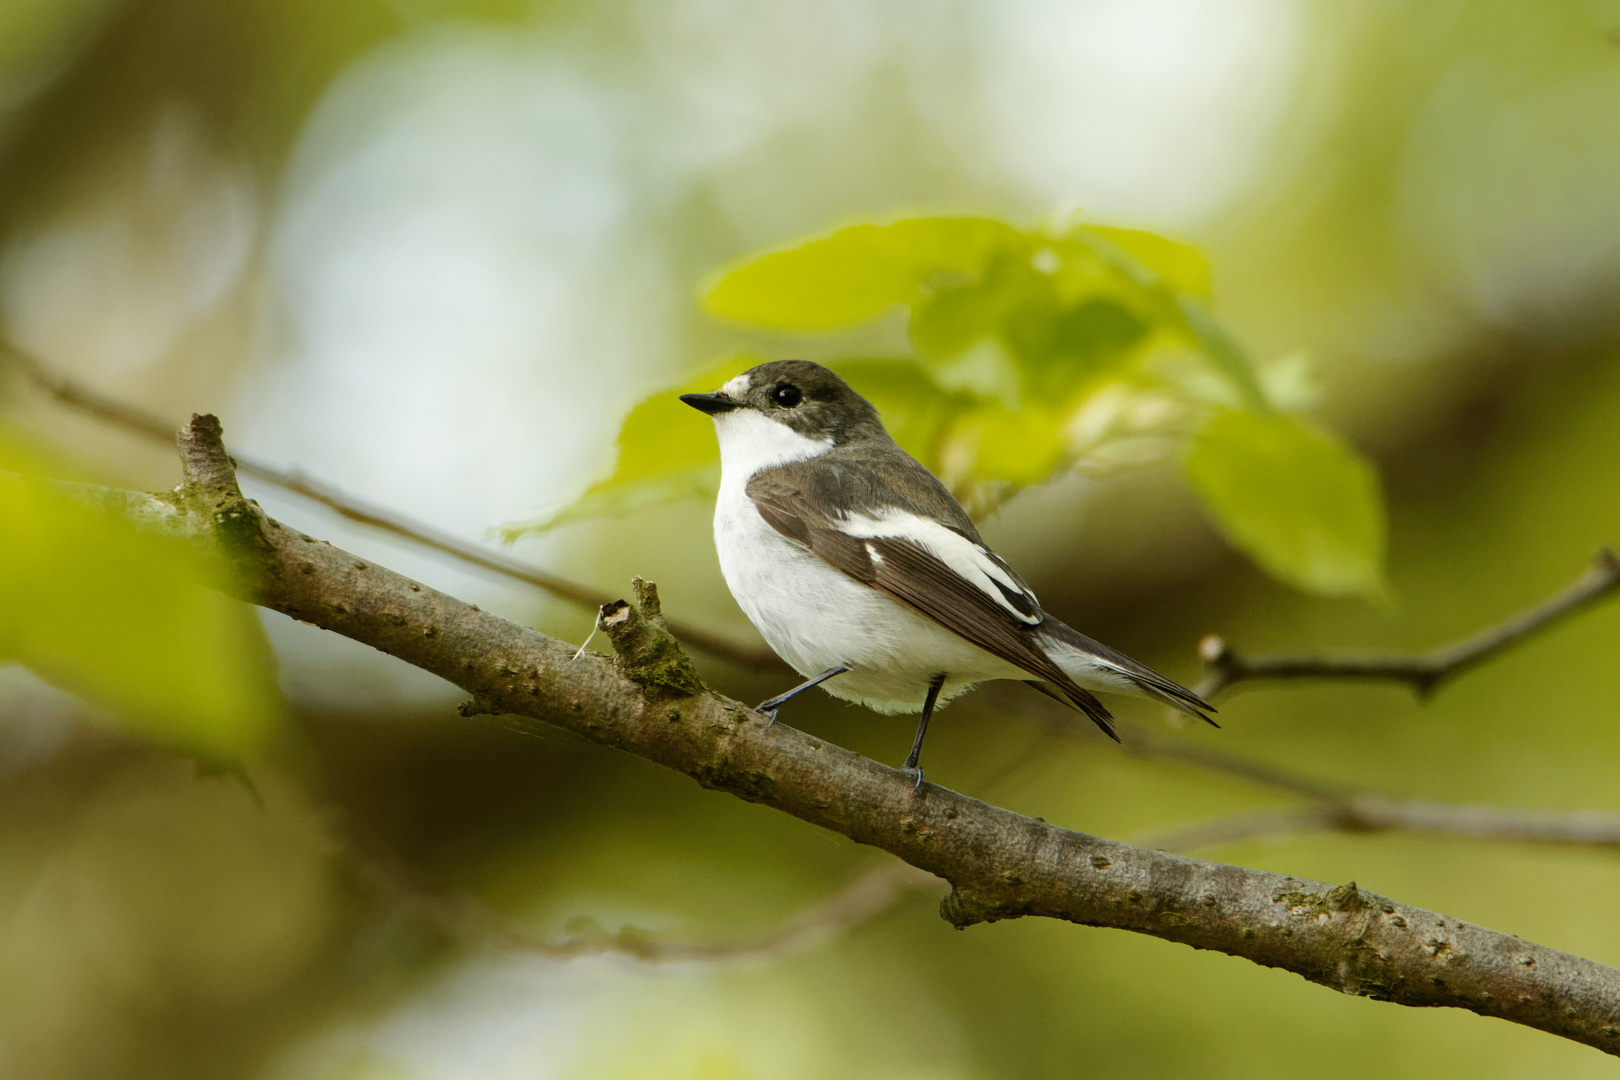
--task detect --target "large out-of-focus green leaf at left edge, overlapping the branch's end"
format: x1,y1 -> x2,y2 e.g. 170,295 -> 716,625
0,473 -> 280,758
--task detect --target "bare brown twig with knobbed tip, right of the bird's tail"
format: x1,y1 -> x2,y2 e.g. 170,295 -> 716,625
1194,547 -> 1620,699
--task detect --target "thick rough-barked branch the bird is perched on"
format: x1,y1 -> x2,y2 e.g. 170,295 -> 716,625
145,418 -> 1620,1054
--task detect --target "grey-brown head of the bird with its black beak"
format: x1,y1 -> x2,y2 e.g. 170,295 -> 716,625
680,359 -> 888,447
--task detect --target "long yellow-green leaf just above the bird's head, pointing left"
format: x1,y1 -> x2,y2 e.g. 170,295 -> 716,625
703,217 -> 1025,330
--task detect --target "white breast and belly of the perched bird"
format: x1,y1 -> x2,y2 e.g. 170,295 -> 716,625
714,484 -> 1029,712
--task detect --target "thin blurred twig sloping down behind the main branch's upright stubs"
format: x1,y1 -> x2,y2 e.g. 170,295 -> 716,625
0,340 -> 781,669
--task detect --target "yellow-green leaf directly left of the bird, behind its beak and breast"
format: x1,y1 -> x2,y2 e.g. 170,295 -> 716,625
499,356 -> 760,541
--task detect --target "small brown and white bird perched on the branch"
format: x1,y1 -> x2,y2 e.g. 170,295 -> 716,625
680,359 -> 1213,785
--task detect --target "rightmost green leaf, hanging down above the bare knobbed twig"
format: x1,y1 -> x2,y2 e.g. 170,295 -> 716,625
1186,410 -> 1385,597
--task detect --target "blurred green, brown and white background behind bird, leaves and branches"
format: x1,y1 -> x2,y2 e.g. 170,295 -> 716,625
0,0 -> 1620,1080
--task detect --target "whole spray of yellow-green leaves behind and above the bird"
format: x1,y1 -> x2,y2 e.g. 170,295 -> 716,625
524,217 -> 1383,582
